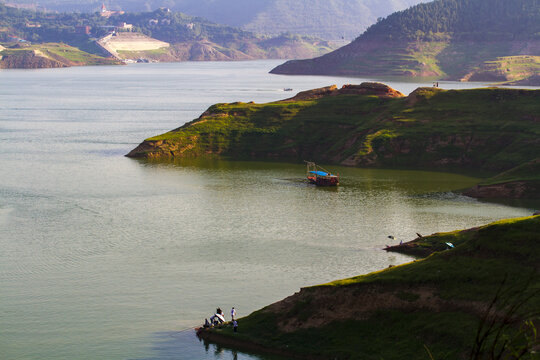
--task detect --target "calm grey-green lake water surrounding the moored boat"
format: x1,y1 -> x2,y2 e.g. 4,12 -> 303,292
0,61 -> 531,359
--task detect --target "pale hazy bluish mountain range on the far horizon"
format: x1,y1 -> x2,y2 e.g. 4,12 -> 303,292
3,0 -> 427,40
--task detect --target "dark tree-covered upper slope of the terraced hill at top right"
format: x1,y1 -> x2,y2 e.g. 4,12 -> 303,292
363,0 -> 540,41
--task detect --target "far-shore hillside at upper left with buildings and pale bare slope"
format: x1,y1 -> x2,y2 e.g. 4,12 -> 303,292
0,4 -> 335,65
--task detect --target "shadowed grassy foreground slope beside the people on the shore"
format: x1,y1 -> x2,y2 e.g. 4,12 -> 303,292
199,216 -> 540,360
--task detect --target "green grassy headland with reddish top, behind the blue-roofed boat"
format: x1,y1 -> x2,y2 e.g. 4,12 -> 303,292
128,83 -> 540,198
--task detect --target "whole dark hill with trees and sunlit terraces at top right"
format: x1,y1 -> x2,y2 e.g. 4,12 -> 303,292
272,0 -> 540,85
